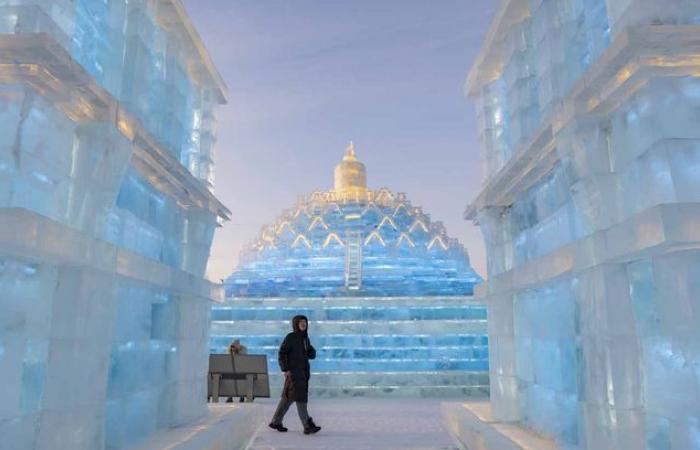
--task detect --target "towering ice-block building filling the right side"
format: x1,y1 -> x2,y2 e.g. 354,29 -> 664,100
466,0 -> 700,450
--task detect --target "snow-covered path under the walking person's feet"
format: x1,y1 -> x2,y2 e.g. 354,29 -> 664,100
250,398 -> 458,450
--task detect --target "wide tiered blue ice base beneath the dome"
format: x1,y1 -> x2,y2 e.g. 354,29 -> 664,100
211,297 -> 488,397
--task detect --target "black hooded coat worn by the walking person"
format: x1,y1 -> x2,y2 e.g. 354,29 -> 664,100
279,315 -> 316,402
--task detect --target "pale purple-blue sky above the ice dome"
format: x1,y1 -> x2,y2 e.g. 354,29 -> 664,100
184,0 -> 498,280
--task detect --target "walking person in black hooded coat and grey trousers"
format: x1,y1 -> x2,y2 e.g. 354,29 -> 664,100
269,315 -> 321,434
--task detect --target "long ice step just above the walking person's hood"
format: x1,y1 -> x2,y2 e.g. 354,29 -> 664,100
211,305 -> 486,321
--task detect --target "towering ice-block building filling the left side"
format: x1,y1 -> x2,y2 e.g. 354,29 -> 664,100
0,0 -> 228,450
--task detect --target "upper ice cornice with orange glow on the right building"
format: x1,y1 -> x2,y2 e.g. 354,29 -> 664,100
464,25 -> 700,220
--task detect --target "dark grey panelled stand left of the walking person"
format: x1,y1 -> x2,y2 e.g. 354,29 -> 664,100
207,354 -> 270,403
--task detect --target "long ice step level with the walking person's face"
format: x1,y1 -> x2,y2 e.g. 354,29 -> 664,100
211,319 -> 486,336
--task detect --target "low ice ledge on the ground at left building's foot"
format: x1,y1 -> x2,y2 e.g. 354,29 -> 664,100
129,403 -> 264,450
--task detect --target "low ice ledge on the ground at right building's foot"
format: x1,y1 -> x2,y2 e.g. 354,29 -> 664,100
441,402 -> 559,450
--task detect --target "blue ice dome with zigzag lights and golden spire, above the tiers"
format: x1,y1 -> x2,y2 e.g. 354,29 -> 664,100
226,143 -> 481,297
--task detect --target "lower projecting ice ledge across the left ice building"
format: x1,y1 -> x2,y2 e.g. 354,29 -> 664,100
0,208 -> 224,302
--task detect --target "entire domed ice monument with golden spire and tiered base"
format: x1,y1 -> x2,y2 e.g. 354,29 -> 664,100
212,146 -> 488,396
